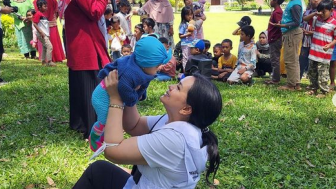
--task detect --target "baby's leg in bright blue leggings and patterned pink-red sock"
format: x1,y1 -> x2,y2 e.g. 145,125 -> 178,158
89,81 -> 110,151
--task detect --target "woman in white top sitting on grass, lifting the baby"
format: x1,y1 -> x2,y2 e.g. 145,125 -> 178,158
73,72 -> 222,189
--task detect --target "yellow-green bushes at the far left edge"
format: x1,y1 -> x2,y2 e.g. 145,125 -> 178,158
1,14 -> 18,48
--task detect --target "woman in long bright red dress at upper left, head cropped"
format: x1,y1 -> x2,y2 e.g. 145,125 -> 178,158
34,0 -> 65,62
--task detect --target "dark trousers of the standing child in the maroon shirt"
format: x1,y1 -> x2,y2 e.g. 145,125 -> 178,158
269,38 -> 282,82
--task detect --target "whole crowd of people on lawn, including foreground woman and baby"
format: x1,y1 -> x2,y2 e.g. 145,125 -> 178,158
0,0 -> 336,188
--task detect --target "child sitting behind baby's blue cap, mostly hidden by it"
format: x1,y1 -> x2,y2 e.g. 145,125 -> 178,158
156,37 -> 176,81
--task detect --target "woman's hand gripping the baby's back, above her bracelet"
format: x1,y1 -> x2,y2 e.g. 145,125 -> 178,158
104,70 -> 122,104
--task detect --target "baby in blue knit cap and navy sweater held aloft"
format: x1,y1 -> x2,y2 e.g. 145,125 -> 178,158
89,37 -> 171,154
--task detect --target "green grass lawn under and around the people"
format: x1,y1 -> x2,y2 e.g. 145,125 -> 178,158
0,14 -> 336,189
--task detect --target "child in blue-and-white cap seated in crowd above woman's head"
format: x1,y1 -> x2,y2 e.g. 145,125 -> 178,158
185,39 -> 209,76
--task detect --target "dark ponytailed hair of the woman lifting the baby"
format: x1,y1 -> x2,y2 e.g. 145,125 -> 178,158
187,73 -> 222,183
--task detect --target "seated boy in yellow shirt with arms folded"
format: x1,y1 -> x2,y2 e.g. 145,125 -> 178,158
218,39 -> 237,82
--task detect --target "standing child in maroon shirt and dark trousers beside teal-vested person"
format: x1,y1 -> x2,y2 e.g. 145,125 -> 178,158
265,0 -> 284,84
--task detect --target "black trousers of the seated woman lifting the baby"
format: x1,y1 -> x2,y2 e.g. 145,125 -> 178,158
73,160 -> 130,189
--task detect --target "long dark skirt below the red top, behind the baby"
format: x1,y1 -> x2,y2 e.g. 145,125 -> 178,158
69,68 -> 100,138
